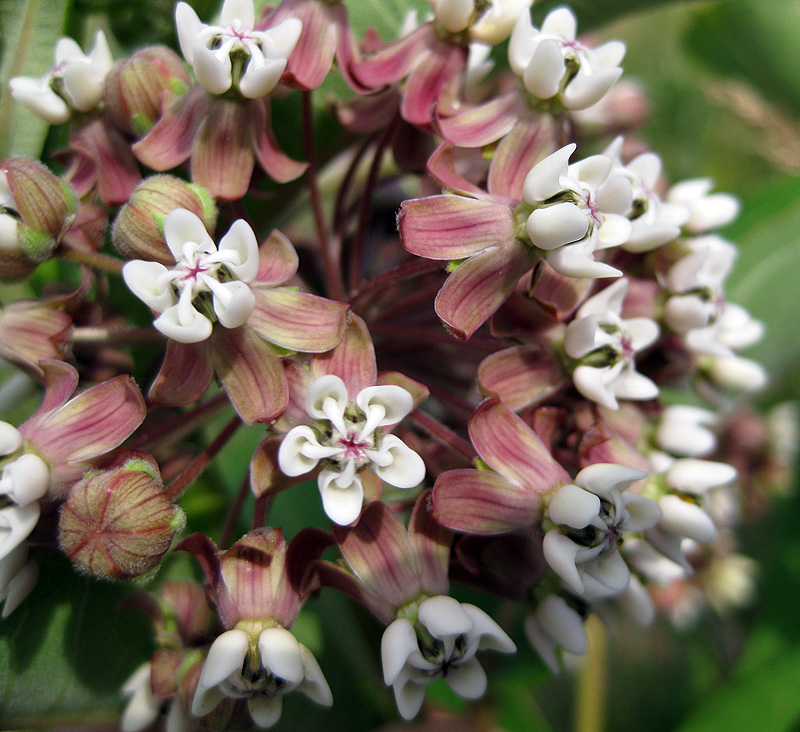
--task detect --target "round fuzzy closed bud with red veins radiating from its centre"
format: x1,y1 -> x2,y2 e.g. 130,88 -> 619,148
59,458 -> 185,579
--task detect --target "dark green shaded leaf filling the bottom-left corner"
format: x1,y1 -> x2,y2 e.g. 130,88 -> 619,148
0,555 -> 152,729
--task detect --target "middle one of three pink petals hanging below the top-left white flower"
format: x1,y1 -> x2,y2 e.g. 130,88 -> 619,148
192,99 -> 255,201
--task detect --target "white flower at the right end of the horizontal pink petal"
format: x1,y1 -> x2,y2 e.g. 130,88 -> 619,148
522,143 -> 633,277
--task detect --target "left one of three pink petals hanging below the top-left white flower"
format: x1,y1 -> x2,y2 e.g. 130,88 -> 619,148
133,84 -> 212,170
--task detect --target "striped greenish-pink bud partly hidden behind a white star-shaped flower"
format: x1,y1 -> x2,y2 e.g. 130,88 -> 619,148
111,175 -> 217,265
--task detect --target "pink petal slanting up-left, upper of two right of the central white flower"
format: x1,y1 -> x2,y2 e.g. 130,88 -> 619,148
469,399 -> 570,494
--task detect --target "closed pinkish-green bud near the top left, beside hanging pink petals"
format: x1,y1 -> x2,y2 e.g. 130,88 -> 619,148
104,46 -> 189,138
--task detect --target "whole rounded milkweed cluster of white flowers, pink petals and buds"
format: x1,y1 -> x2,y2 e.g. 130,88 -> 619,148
0,0 -> 791,732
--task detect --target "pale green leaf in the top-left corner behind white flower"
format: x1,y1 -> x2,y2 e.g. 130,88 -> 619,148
0,0 -> 69,159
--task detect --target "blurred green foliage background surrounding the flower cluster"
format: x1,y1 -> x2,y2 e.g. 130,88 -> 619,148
0,0 -> 800,732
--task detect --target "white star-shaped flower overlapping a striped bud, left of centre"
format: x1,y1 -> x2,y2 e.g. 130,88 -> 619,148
122,209 -> 258,343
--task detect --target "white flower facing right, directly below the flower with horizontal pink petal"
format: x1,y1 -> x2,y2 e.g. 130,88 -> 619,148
564,279 -> 658,409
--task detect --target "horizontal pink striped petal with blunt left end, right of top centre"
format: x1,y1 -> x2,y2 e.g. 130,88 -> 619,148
399,195 -> 514,260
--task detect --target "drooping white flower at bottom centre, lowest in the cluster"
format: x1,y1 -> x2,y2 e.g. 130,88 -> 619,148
381,595 -> 516,719
